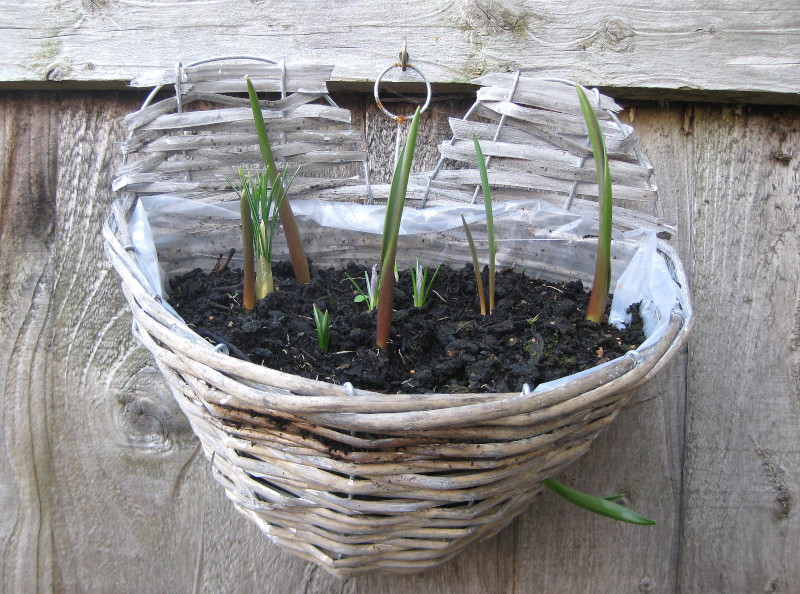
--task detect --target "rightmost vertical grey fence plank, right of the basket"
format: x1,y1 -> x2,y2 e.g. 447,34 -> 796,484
679,106 -> 800,592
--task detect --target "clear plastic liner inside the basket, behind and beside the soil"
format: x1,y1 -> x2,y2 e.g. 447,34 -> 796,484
131,195 -> 680,349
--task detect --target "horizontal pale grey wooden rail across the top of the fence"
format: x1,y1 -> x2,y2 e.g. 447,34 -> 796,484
0,0 -> 800,104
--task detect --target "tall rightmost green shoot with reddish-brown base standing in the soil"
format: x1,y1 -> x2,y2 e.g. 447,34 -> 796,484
575,85 -> 612,322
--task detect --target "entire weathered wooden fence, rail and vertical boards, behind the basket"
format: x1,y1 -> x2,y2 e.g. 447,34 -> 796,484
0,0 -> 800,594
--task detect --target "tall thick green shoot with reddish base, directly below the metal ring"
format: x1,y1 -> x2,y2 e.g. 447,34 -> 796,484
375,108 -> 420,349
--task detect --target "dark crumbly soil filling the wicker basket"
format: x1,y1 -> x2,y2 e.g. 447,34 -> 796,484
170,263 -> 644,393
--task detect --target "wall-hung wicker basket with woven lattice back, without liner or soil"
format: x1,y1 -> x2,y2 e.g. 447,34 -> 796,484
103,61 -> 692,576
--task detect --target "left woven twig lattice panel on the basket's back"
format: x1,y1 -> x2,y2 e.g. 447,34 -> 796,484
113,60 -> 368,201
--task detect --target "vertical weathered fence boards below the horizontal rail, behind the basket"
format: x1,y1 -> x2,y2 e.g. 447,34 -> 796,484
0,86 -> 800,594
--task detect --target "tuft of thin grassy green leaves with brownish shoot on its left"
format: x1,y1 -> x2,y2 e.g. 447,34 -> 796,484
234,167 -> 294,300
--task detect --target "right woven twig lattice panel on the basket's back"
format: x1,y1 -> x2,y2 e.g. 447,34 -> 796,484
422,72 -> 658,215
